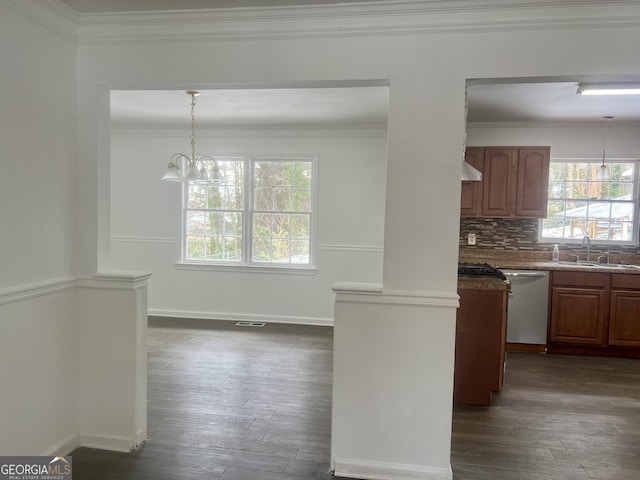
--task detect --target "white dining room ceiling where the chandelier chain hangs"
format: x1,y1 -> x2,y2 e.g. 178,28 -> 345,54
111,86 -> 389,126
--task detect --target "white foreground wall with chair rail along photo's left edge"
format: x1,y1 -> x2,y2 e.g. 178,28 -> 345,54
0,2 -> 78,455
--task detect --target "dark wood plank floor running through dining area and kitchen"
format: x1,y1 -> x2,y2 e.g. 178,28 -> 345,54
72,319 -> 640,480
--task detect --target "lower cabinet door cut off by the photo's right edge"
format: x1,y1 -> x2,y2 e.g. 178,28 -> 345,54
609,290 -> 640,347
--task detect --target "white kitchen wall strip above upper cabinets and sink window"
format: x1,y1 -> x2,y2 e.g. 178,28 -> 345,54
467,121 -> 640,159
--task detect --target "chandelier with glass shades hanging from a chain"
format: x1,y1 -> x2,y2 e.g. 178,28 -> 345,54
162,90 -> 222,185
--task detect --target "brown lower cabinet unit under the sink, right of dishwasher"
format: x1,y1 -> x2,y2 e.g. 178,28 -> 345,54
548,271 -> 640,357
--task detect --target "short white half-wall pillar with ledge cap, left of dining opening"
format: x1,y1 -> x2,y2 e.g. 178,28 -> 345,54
78,273 -> 150,452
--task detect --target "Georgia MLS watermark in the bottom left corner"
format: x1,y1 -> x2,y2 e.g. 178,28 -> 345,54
0,456 -> 72,480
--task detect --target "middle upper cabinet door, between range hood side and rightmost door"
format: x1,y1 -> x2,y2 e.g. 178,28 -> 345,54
482,148 -> 518,217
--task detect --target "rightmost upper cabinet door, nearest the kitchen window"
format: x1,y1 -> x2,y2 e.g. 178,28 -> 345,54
516,147 -> 550,218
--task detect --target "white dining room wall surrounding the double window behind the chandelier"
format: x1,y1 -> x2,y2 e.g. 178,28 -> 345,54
111,125 -> 386,324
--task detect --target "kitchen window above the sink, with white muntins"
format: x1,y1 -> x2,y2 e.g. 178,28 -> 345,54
540,160 -> 638,243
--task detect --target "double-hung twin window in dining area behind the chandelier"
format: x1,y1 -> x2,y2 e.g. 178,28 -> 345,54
183,157 -> 315,268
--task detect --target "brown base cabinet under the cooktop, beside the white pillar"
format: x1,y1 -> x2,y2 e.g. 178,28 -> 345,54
453,280 -> 508,405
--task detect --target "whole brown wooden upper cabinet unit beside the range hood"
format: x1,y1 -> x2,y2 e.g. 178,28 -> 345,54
460,143 -> 550,218
